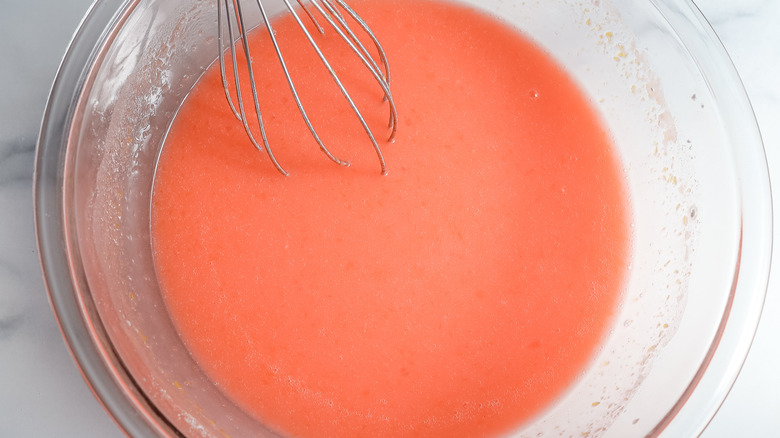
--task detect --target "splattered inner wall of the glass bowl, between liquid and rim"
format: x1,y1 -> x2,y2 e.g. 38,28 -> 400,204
43,0 -> 763,437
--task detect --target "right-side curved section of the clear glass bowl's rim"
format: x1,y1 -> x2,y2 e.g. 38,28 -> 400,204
650,0 -> 773,436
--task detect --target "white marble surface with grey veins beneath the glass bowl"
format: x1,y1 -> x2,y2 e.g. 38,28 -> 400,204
0,0 -> 780,438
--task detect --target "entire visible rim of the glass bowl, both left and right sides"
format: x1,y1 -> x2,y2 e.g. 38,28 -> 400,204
33,0 -> 773,436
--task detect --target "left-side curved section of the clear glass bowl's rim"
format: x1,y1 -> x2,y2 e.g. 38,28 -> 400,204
33,0 -> 183,436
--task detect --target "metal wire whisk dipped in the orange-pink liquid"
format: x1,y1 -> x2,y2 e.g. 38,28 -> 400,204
217,0 -> 398,175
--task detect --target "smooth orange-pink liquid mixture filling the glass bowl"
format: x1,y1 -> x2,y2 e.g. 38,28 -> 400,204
152,0 -> 630,437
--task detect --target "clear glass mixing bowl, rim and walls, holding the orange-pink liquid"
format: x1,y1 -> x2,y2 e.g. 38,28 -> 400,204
35,0 -> 771,438
